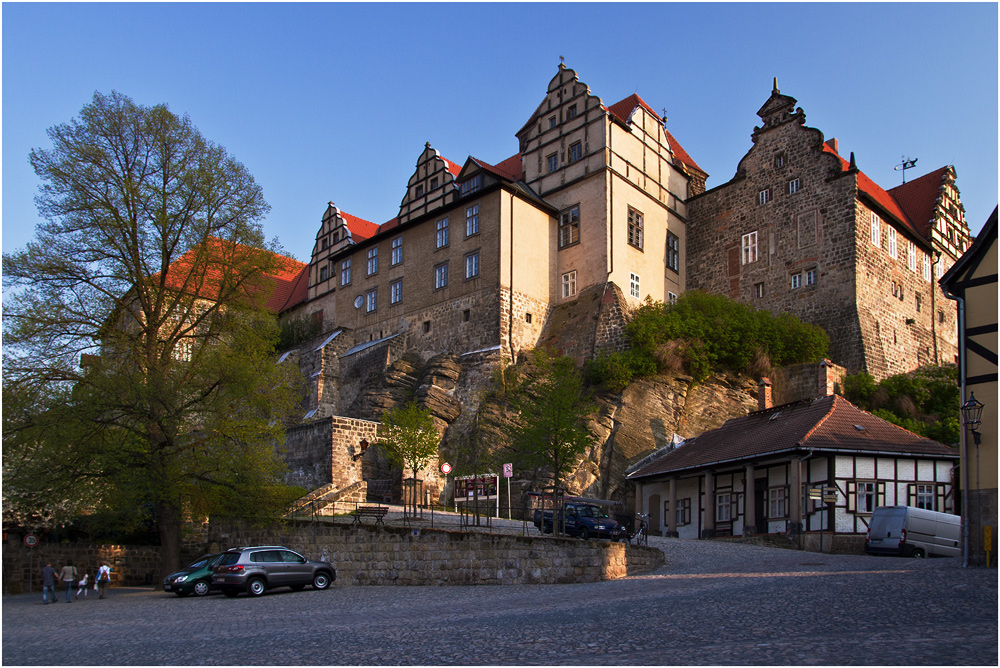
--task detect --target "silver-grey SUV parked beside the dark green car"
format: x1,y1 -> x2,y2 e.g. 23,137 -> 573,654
212,545 -> 337,596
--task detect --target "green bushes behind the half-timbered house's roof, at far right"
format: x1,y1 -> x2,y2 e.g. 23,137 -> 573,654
843,366 -> 961,445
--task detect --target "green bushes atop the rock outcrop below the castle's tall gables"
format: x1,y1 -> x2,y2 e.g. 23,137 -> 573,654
587,291 -> 830,392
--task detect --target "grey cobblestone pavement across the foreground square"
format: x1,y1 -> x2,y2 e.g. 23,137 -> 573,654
2,538 -> 998,666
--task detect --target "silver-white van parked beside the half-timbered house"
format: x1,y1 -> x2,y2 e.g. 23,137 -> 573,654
865,506 -> 962,557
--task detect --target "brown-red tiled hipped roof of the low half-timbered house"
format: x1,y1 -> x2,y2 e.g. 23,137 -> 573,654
629,395 -> 958,479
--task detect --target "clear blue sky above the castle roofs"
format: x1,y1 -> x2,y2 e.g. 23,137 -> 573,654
2,2 -> 998,260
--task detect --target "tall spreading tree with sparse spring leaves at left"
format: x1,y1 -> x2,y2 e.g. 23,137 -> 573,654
3,92 -> 297,572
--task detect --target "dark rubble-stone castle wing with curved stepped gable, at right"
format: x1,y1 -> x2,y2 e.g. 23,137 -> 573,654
687,81 -> 970,379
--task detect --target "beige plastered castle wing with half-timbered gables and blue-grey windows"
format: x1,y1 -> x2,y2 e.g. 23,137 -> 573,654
283,65 -> 707,378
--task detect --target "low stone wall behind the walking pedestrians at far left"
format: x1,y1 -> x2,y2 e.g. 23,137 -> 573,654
3,531 -> 160,595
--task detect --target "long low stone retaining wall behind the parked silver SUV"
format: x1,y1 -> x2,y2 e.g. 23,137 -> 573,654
206,519 -> 665,586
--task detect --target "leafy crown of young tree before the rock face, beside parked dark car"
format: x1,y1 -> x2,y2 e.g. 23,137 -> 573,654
507,349 -> 596,486
